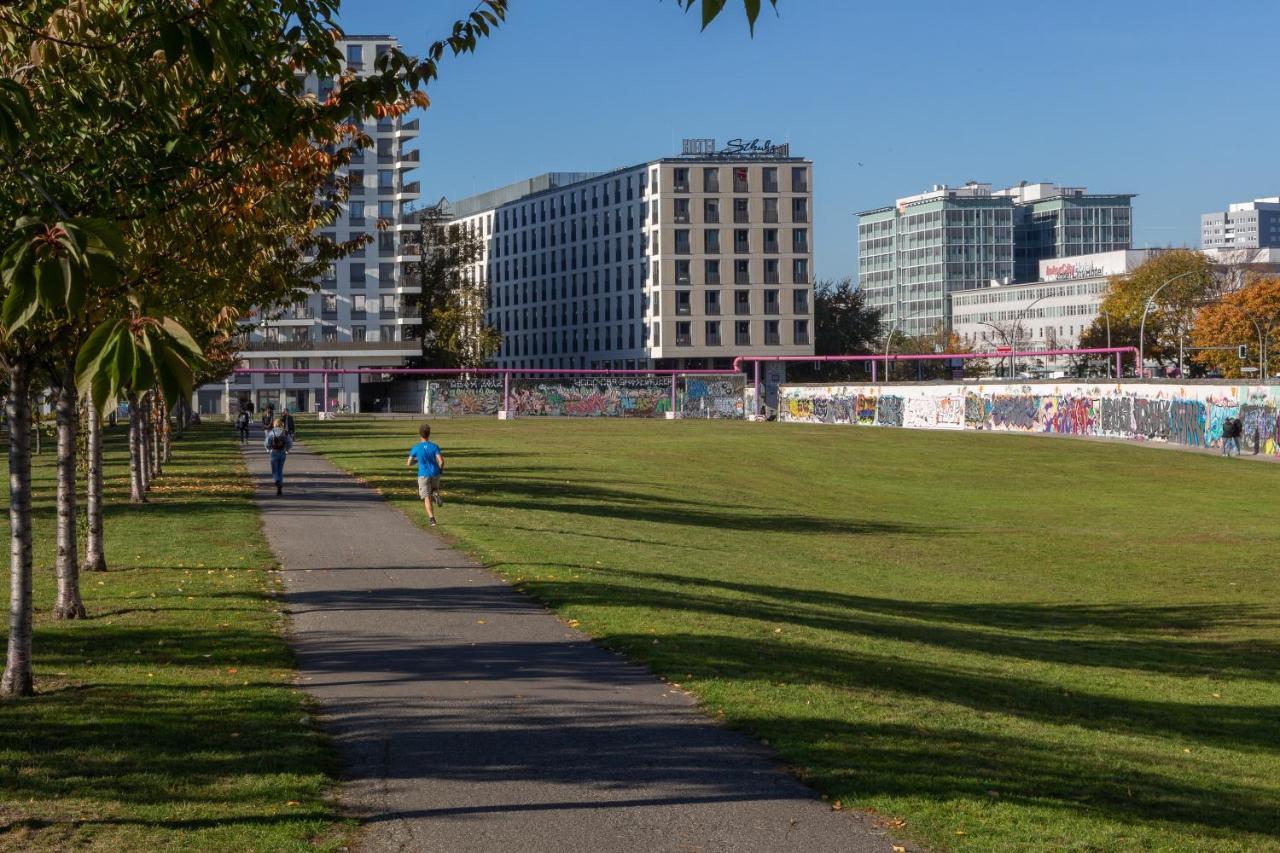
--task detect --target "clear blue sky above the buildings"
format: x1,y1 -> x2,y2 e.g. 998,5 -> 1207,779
342,0 -> 1280,278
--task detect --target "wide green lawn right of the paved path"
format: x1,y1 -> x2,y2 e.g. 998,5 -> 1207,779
301,419 -> 1280,850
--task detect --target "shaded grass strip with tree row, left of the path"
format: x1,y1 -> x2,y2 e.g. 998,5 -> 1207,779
0,425 -> 346,850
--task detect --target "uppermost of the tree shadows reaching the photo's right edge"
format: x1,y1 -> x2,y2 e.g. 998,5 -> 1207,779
519,564 -> 1280,681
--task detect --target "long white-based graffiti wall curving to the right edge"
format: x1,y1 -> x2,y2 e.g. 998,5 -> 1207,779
778,382 -> 1280,456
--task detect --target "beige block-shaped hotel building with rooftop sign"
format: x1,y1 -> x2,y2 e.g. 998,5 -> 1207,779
449,147 -> 813,369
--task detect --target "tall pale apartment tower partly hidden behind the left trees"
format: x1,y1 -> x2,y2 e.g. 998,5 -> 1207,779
197,36 -> 421,414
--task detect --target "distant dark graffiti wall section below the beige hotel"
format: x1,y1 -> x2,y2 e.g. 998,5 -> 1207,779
428,377 -> 745,418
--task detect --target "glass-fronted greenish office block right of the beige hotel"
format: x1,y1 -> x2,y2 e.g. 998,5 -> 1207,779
858,182 -> 1133,334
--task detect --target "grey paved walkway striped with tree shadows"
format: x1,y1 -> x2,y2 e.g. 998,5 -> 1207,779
247,430 -> 891,853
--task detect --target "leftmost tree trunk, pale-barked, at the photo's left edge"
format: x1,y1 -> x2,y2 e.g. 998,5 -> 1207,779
0,364 -> 35,695
